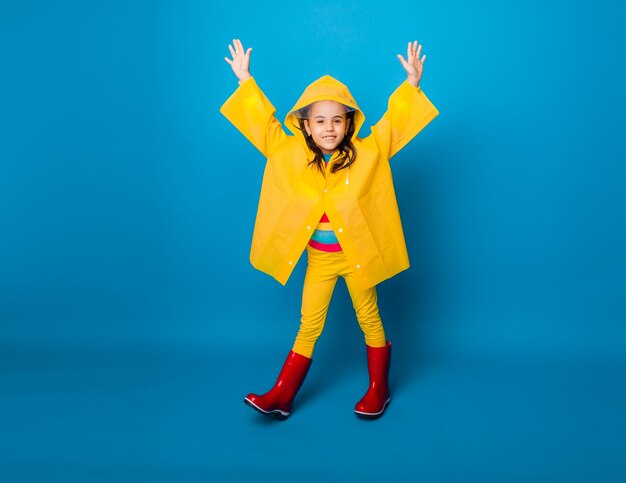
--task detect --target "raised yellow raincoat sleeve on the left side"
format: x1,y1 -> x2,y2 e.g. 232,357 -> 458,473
220,77 -> 287,157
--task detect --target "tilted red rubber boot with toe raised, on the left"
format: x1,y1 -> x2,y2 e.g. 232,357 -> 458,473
243,351 -> 312,419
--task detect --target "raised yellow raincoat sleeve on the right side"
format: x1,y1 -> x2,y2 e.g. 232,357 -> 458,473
372,81 -> 439,158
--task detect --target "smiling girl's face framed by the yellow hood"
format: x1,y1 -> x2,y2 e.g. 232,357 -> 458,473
304,101 -> 350,154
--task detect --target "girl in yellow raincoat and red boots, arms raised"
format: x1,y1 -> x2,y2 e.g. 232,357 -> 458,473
220,39 -> 439,419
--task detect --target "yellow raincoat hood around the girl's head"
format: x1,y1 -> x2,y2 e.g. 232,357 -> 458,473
285,75 -> 365,139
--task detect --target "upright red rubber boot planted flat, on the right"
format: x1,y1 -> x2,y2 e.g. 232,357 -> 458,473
354,342 -> 391,418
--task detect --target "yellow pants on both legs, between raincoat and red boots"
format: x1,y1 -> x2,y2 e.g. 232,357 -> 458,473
292,246 -> 387,358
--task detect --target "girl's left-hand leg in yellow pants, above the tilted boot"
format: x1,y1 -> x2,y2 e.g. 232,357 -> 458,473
293,247 -> 340,358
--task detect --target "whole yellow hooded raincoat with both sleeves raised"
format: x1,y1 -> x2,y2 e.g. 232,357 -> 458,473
220,76 -> 439,288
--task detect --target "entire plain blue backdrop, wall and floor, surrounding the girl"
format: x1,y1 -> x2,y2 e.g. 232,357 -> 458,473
0,0 -> 626,482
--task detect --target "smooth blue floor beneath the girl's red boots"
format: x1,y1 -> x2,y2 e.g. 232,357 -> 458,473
0,345 -> 626,483
